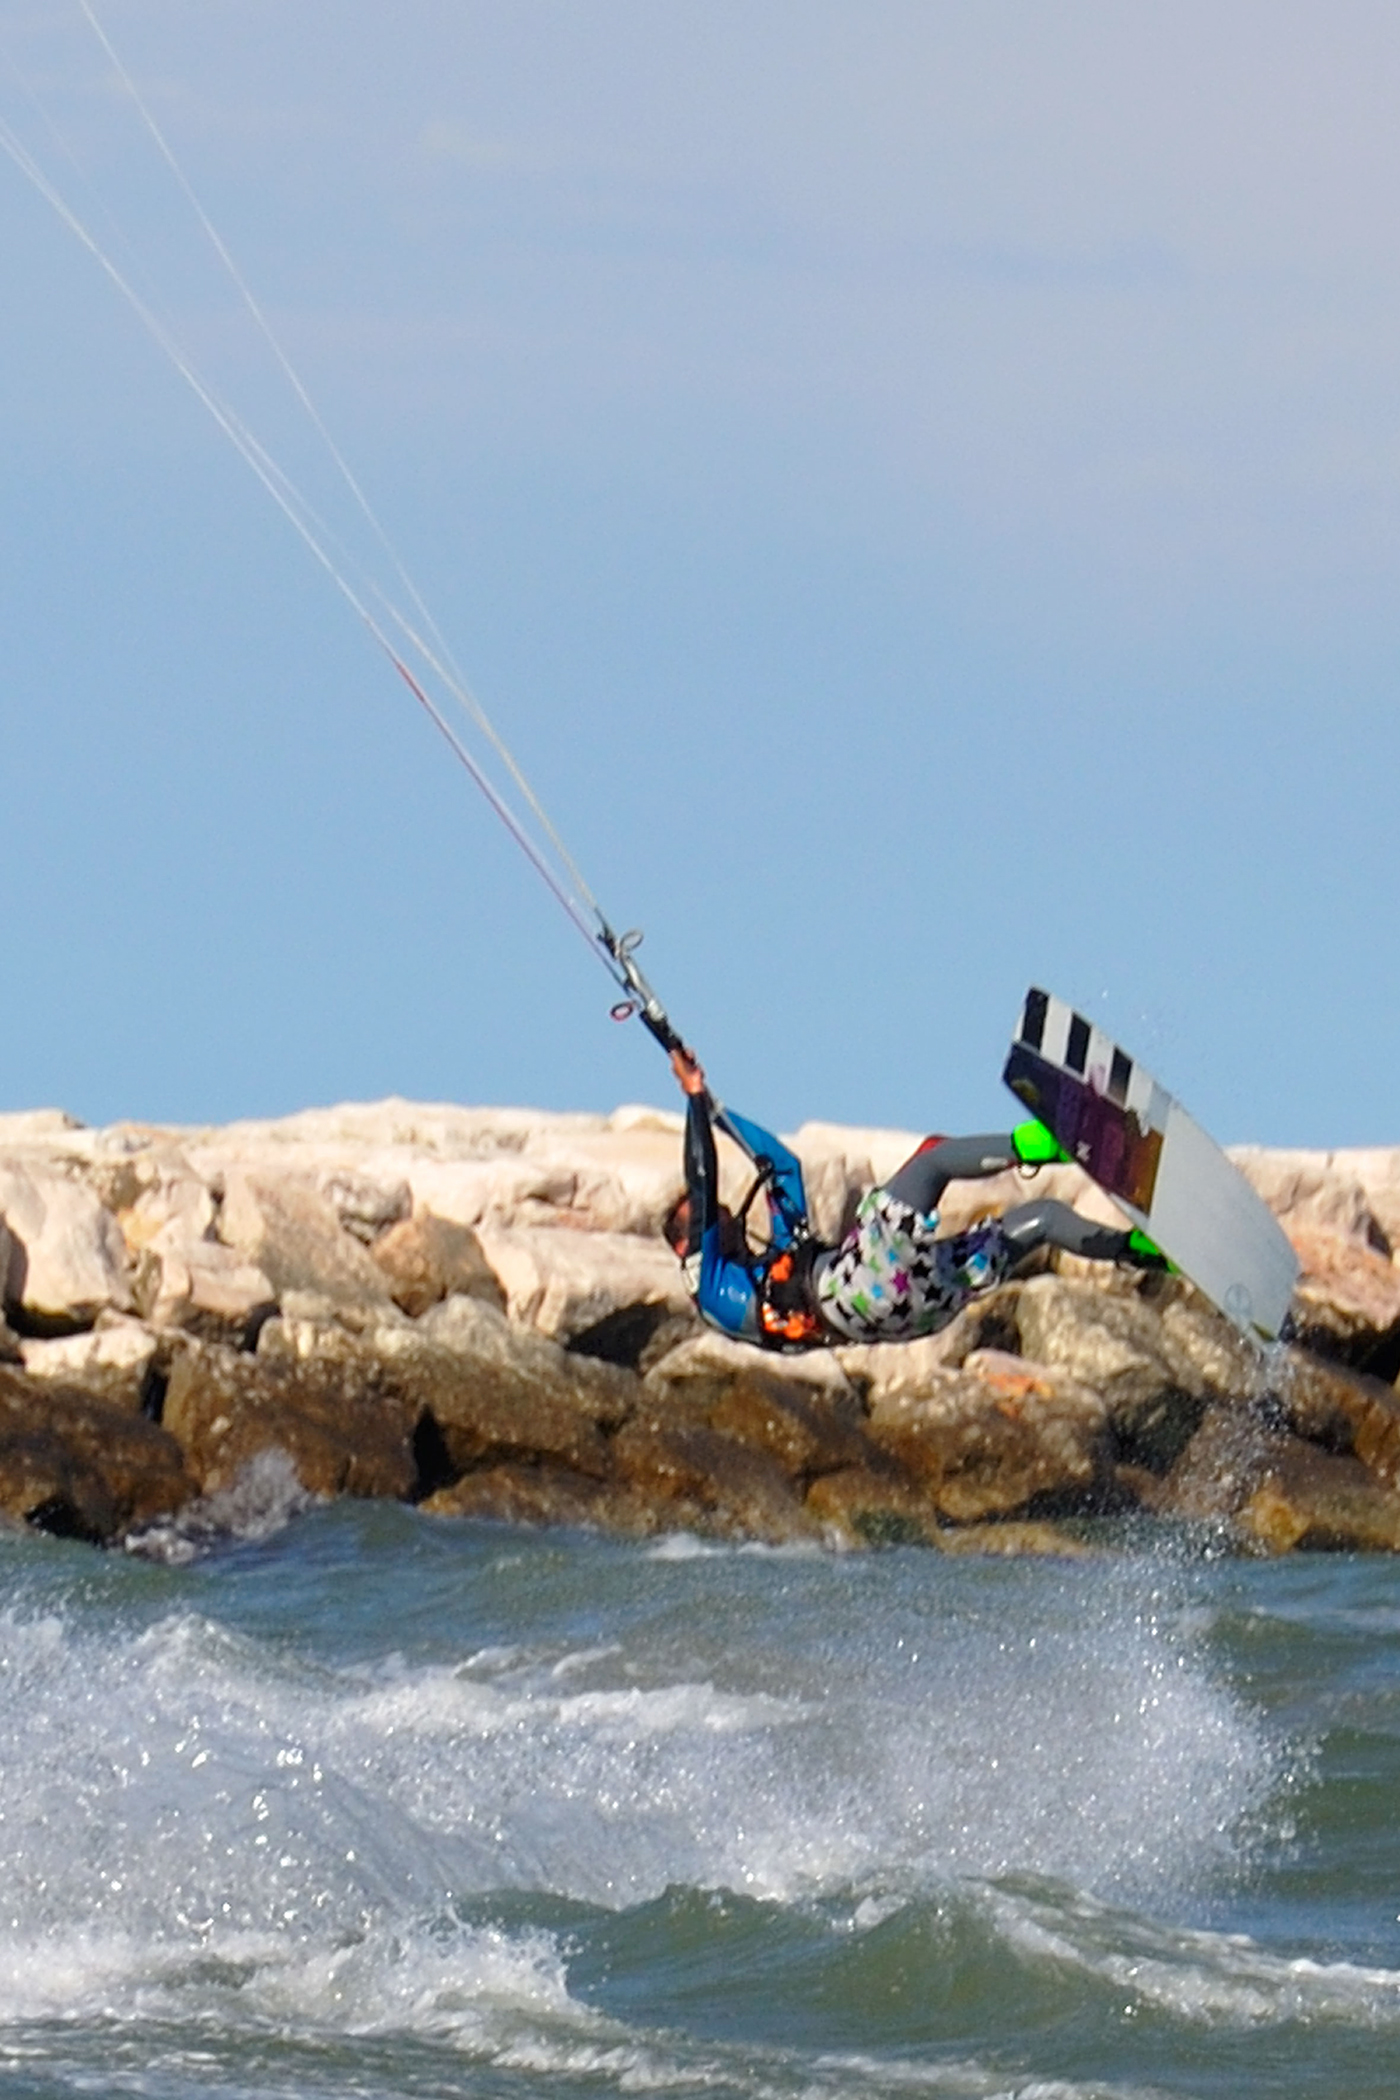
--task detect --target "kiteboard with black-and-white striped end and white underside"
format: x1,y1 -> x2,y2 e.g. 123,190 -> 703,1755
1001,987 -> 1297,1342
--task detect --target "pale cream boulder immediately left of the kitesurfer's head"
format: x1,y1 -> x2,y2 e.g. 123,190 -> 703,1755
481,1226 -> 691,1350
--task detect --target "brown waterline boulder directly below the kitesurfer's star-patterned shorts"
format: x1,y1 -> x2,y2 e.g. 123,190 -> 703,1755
869,1350 -> 1110,1525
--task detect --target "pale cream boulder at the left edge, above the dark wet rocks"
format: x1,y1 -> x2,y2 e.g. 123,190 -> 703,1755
0,1159 -> 132,1334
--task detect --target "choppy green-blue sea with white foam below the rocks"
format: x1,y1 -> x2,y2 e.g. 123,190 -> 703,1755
0,1472 -> 1400,2100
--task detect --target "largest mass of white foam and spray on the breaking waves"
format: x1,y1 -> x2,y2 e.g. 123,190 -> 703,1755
0,1556 -> 1284,2096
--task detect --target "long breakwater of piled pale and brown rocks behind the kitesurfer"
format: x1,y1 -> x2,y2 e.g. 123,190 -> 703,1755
0,1100 -> 1400,1552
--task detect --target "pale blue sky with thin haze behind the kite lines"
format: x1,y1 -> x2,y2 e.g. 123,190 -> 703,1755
0,0 -> 1400,1145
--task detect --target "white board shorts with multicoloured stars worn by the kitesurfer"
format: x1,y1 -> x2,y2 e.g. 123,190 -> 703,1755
816,1189 -> 1016,1342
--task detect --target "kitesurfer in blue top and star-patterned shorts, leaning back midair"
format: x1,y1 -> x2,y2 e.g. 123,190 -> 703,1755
665,1048 -> 1167,1350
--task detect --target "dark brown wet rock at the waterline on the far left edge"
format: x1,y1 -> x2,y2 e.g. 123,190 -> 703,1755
0,1367 -> 193,1544
